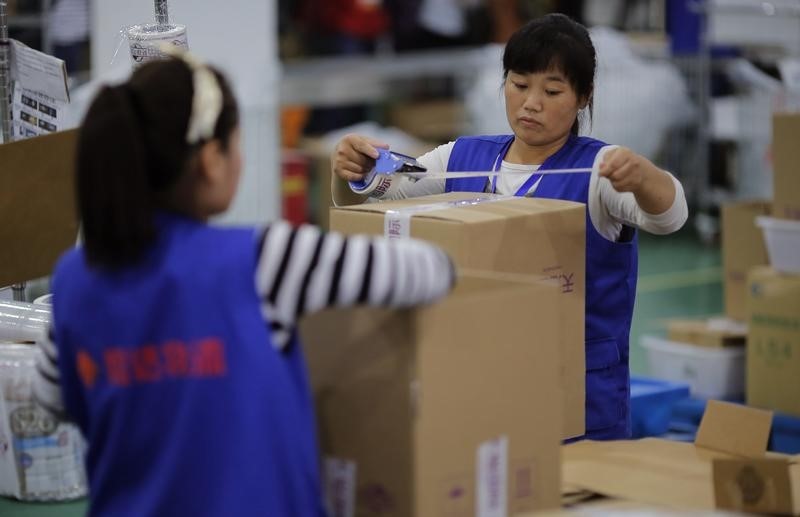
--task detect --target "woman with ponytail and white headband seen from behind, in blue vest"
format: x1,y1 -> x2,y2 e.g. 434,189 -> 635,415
34,50 -> 454,517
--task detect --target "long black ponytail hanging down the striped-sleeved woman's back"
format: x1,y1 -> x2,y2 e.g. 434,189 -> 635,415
77,85 -> 155,268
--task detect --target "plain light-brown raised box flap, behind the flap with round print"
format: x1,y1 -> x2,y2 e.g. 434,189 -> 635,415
694,400 -> 772,458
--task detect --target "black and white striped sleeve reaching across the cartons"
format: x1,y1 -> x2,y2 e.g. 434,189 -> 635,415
256,222 -> 455,348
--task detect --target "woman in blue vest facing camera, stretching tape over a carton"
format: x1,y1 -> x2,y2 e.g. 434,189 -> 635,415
331,14 -> 687,439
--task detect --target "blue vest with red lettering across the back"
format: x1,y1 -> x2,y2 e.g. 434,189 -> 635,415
53,215 -> 324,516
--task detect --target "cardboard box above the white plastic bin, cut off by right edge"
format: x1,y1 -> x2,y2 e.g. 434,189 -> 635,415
772,113 -> 800,219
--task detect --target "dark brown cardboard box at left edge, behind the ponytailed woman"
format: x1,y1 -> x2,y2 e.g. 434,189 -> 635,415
0,131 -> 78,287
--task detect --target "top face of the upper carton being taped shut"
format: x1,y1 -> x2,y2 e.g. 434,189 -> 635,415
335,192 -> 584,222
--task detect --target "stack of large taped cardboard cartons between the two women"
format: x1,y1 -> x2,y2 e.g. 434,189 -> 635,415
302,193 -> 586,516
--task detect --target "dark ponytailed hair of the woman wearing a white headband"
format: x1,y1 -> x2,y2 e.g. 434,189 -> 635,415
76,58 -> 239,268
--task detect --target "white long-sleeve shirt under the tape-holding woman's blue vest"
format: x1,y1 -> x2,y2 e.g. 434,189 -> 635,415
366,142 -> 689,241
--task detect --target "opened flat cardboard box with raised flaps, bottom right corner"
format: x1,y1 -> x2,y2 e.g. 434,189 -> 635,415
563,400 -> 800,515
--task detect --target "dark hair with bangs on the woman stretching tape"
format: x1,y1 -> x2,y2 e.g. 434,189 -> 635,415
503,13 -> 597,134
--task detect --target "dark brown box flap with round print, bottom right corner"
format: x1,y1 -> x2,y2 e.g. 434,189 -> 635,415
713,458 -> 797,515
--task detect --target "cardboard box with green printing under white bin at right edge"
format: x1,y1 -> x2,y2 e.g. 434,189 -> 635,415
746,267 -> 800,416
